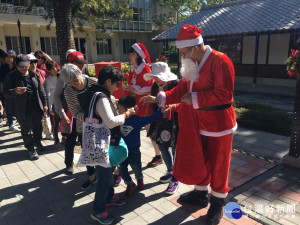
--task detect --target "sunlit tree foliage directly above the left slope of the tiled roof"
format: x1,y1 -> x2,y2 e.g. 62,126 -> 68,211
153,0 -> 235,26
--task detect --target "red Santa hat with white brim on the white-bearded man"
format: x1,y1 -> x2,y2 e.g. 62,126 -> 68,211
175,24 -> 203,48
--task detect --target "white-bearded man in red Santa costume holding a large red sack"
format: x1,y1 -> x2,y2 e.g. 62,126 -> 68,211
143,24 -> 237,224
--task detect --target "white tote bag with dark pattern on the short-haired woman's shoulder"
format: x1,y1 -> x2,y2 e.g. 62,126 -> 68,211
77,92 -> 110,167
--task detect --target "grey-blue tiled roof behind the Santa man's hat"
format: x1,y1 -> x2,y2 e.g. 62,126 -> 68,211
153,0 -> 300,41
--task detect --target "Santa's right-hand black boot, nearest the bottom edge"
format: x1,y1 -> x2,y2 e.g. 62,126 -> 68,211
206,195 -> 225,225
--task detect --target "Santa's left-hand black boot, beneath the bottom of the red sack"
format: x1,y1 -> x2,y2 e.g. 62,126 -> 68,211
178,190 -> 208,209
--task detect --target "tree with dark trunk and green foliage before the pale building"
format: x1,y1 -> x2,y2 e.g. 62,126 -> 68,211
31,0 -> 133,64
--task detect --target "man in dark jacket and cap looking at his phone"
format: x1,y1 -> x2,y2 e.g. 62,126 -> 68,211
4,54 -> 48,160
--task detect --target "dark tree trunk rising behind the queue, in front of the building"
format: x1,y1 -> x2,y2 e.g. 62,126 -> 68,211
53,0 -> 75,66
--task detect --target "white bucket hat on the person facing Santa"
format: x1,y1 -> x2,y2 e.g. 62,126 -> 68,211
143,62 -> 178,82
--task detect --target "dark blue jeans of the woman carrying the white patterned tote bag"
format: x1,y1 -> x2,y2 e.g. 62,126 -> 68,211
93,166 -> 114,213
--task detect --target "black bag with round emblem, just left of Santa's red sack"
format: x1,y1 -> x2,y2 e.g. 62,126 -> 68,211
156,118 -> 173,147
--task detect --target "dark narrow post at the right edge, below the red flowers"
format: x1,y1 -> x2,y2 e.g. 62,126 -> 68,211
289,79 -> 300,158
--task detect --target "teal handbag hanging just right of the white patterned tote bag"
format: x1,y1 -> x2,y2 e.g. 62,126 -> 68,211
108,138 -> 128,166
